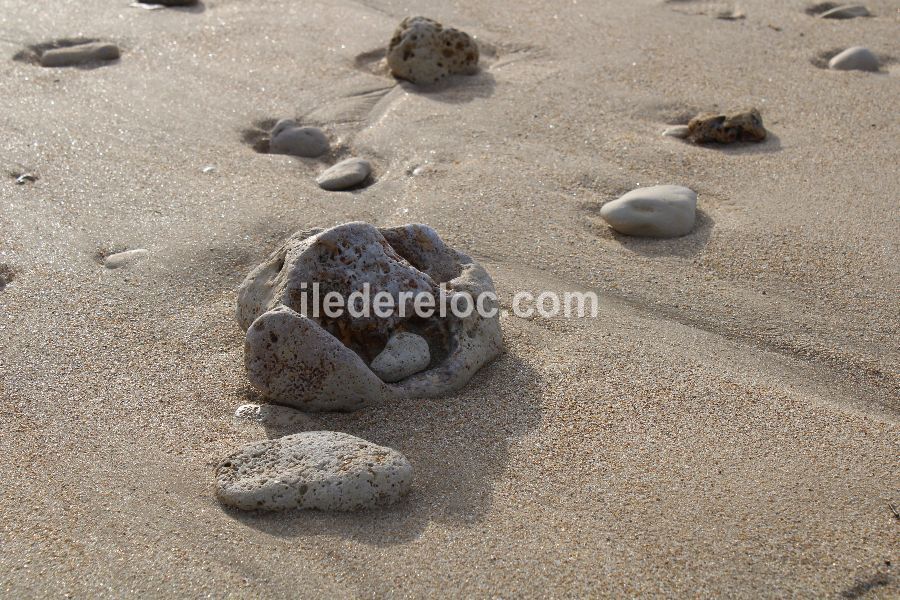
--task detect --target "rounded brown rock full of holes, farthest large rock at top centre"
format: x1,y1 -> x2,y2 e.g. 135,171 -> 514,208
387,17 -> 478,84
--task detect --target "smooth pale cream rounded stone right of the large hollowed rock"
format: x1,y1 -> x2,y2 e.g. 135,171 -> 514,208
600,185 -> 697,238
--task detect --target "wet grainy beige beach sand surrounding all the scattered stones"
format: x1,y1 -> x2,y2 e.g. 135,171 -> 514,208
0,0 -> 900,598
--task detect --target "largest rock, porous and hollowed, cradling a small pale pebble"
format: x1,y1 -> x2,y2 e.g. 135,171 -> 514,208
237,223 -> 502,410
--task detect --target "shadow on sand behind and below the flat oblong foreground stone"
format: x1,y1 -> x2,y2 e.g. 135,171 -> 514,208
223,353 -> 541,546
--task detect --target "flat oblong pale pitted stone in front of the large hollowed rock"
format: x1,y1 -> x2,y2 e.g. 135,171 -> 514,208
216,431 -> 412,511
